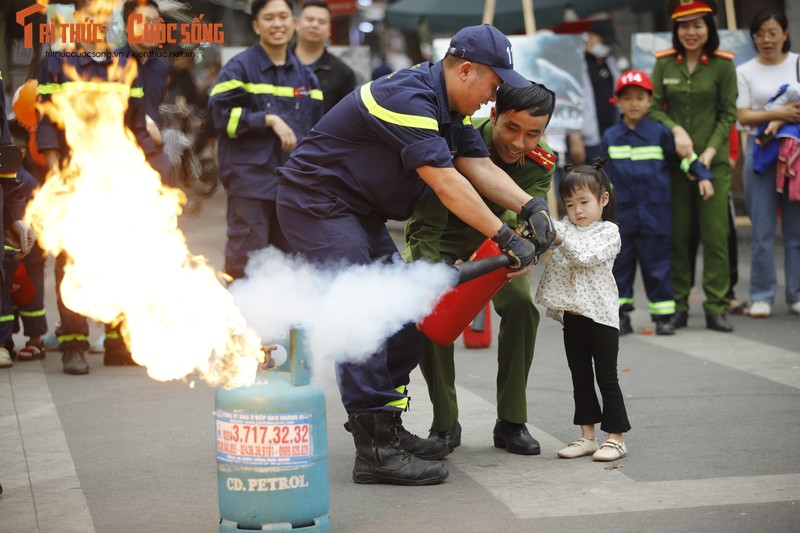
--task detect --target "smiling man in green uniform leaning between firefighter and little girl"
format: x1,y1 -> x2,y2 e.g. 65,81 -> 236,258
403,83 -> 556,455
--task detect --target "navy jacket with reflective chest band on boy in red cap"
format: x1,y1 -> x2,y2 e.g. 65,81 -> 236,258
601,117 -> 678,235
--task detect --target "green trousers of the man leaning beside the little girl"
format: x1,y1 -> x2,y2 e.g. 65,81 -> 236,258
419,276 -> 539,431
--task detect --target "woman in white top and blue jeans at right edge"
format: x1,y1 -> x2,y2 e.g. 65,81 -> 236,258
736,8 -> 800,318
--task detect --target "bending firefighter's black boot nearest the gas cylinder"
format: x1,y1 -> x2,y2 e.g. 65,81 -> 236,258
348,412 -> 449,486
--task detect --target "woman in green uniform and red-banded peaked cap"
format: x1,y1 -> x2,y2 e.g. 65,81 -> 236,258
649,0 -> 737,332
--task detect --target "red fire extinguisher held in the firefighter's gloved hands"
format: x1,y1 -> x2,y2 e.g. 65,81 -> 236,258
419,239 -> 512,345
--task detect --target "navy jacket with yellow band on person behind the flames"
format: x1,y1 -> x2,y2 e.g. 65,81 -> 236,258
36,48 -> 155,160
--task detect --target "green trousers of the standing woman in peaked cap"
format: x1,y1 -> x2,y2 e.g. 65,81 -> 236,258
672,165 -> 731,314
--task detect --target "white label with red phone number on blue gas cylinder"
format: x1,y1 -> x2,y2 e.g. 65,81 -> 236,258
216,409 -> 312,466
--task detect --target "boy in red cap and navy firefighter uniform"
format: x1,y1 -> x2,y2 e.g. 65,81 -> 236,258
601,70 -> 678,335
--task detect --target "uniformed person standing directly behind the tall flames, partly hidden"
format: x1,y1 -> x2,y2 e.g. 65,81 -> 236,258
36,0 -> 160,375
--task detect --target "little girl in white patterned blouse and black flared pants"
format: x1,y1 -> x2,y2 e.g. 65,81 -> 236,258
536,158 -> 631,461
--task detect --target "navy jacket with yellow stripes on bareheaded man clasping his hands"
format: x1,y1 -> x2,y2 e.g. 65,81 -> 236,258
208,43 -> 322,200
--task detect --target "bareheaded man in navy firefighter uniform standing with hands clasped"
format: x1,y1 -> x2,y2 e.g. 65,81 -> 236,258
209,0 -> 323,279
